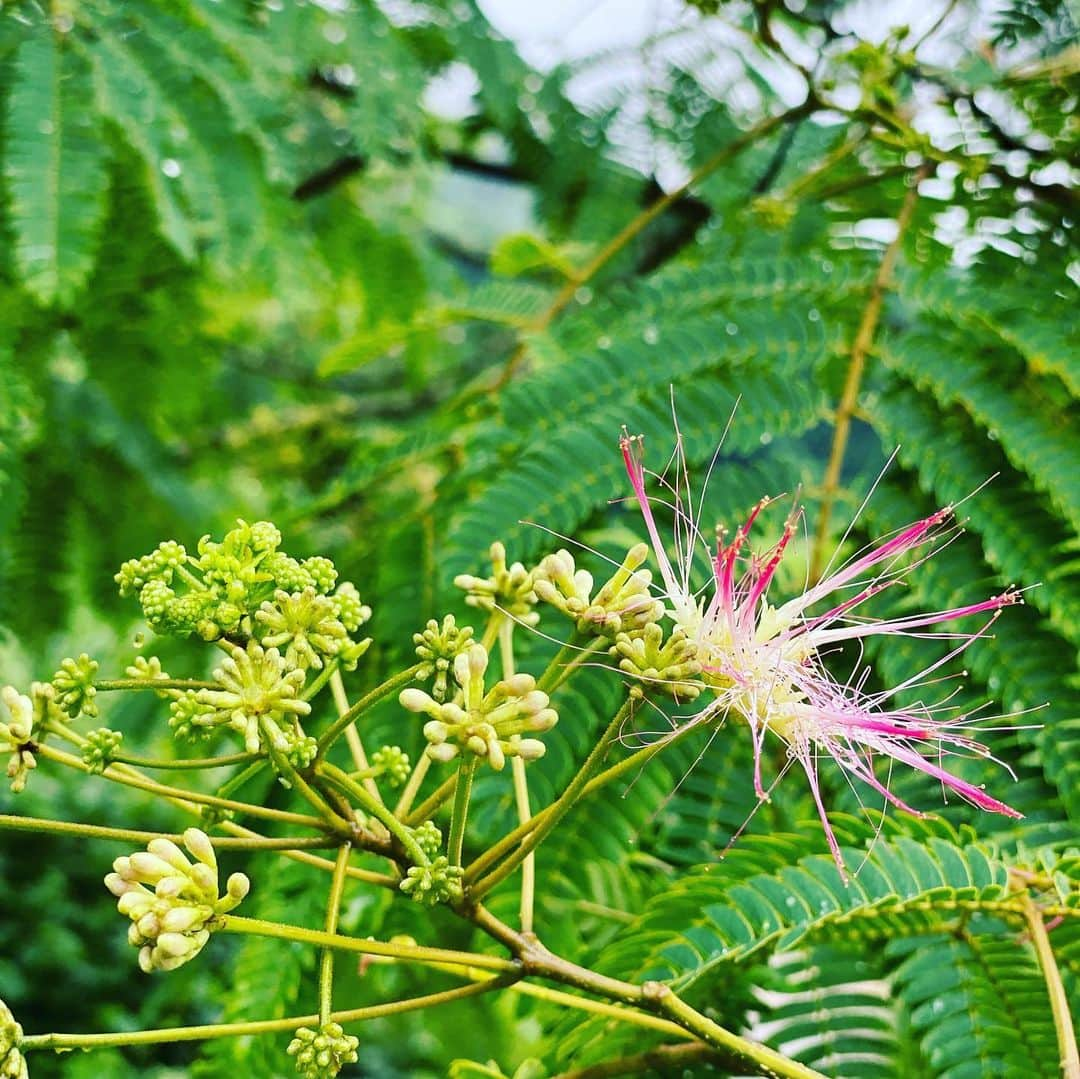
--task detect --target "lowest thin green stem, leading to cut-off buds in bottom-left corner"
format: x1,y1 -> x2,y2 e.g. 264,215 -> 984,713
18,972 -> 518,1052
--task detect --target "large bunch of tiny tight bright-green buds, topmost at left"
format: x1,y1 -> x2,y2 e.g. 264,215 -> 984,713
116,521 -> 370,667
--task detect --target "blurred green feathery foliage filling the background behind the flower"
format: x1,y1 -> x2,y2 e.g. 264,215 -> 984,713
0,0 -> 1080,1079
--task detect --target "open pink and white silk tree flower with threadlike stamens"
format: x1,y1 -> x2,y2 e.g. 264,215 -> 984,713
620,432 -> 1022,874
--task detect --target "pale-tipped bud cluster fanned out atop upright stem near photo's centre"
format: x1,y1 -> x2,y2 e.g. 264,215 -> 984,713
399,645 -> 558,771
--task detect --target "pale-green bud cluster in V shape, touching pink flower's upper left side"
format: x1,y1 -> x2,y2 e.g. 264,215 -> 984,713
534,543 -> 664,638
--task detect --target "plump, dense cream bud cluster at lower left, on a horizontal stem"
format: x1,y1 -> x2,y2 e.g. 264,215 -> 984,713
105,828 -> 251,974
